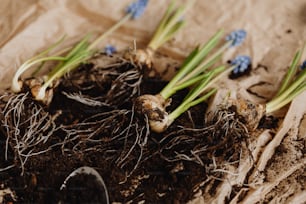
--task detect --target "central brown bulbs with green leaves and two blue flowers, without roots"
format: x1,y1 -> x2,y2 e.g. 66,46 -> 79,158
135,29 -> 250,132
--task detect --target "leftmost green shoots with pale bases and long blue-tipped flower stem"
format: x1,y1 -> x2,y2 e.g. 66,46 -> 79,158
11,0 -> 148,101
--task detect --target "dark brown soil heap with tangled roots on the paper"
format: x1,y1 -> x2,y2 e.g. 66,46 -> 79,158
0,53 -> 247,203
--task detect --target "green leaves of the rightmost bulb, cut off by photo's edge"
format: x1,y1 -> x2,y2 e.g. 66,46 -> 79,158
266,46 -> 306,114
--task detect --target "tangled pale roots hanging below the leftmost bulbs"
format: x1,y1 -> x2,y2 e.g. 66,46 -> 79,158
0,93 -> 59,174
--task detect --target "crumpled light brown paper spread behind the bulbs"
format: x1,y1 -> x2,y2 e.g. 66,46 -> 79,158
0,0 -> 306,202
